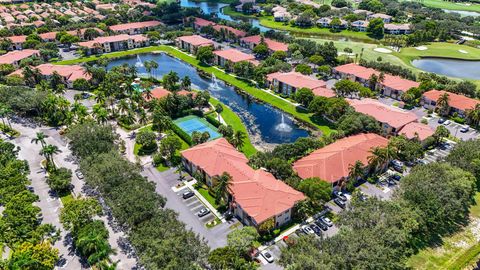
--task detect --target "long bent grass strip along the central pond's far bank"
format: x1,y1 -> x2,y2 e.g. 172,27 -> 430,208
55,45 -> 333,135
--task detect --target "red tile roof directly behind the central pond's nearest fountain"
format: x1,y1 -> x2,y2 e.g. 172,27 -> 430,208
267,71 -> 335,97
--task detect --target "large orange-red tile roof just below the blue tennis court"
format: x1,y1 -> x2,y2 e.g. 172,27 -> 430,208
182,138 -> 305,224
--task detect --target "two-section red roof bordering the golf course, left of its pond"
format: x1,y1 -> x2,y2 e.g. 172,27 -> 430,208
334,63 -> 420,92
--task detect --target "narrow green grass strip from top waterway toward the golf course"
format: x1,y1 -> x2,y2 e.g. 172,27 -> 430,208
259,16 -> 377,43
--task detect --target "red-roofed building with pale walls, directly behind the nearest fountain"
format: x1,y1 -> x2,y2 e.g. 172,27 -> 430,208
267,71 -> 335,97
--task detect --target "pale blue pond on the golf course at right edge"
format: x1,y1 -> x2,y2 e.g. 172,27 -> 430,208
412,58 -> 480,80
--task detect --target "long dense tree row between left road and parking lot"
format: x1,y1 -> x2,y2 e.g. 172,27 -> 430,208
67,123 -> 208,269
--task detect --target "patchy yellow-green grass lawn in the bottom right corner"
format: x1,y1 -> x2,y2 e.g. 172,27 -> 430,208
407,193 -> 480,270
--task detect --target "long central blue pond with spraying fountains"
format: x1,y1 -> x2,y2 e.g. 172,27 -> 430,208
107,53 -> 309,149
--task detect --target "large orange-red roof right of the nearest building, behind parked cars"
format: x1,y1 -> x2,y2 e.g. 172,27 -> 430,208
293,133 -> 388,183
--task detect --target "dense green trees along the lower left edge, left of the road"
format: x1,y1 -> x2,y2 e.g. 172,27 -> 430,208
0,140 -> 59,269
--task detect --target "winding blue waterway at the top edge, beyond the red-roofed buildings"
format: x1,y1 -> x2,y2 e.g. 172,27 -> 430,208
180,0 -> 272,32
